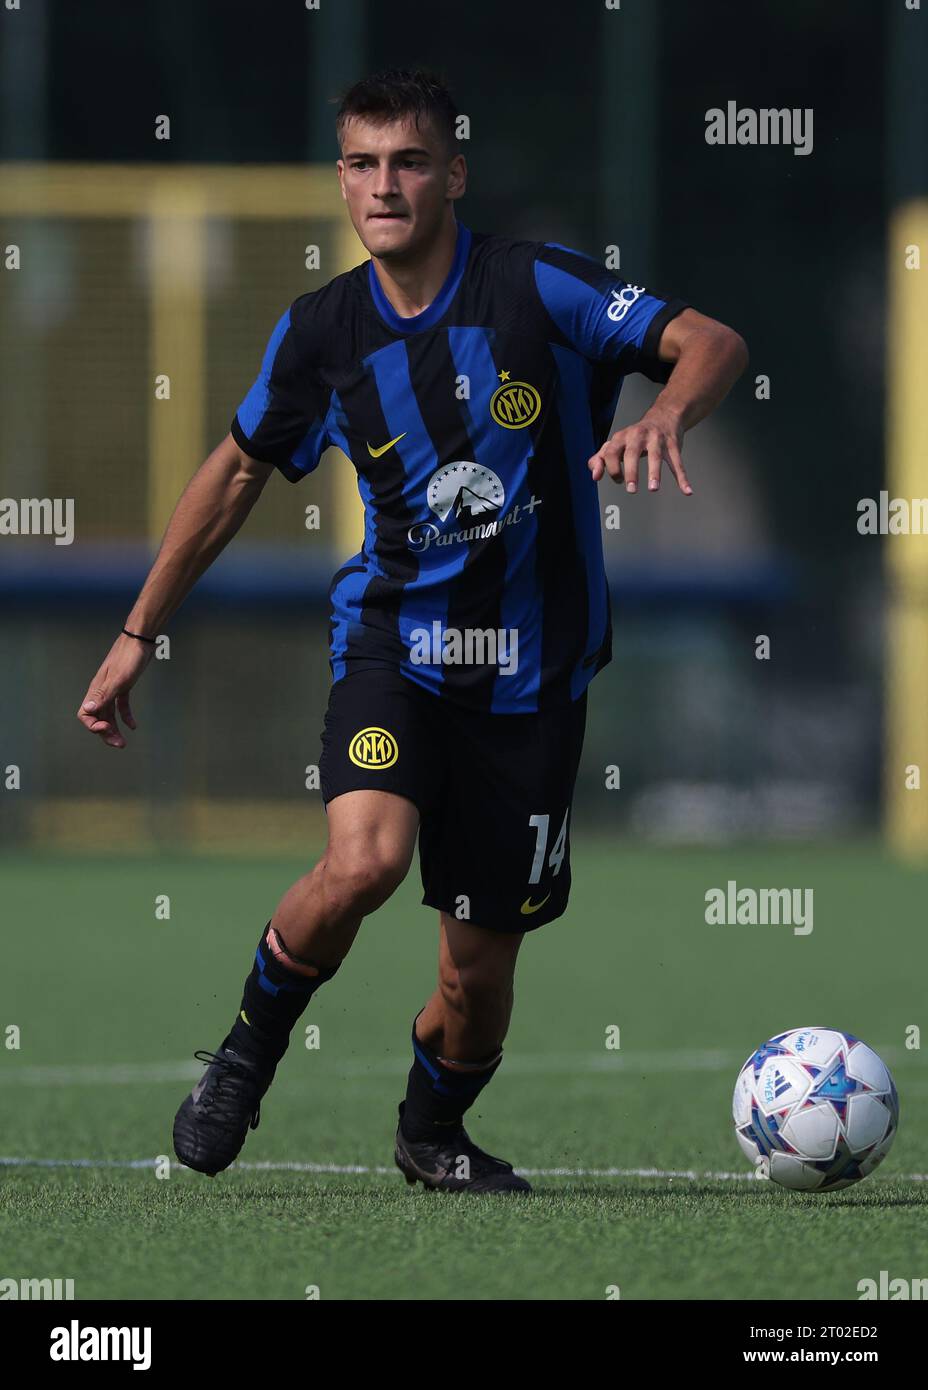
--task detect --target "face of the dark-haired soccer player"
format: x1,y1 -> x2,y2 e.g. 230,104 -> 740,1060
338,117 -> 465,261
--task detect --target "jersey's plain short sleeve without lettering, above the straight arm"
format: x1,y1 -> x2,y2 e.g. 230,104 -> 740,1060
232,300 -> 331,482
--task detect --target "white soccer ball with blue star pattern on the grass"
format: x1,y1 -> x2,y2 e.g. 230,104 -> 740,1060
732,1029 -> 899,1193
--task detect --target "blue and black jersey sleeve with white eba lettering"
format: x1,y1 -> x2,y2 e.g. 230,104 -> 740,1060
535,242 -> 688,381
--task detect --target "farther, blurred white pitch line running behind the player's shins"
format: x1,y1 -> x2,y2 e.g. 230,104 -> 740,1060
0,1043 -> 913,1087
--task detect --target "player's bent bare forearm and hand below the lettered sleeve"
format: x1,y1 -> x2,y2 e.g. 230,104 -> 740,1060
588,309 -> 747,496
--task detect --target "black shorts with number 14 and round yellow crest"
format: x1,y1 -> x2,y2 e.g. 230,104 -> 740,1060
320,667 -> 586,933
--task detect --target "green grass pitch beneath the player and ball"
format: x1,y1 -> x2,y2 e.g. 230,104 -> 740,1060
0,830 -> 928,1300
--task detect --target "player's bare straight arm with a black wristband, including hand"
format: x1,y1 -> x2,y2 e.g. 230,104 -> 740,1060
78,434 -> 274,748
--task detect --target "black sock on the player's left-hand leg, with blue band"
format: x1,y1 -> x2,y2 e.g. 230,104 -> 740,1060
224,922 -> 339,1065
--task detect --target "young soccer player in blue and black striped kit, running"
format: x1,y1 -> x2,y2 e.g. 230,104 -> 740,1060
78,71 -> 746,1193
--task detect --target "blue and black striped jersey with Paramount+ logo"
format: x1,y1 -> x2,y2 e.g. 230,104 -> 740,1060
232,224 -> 686,713
